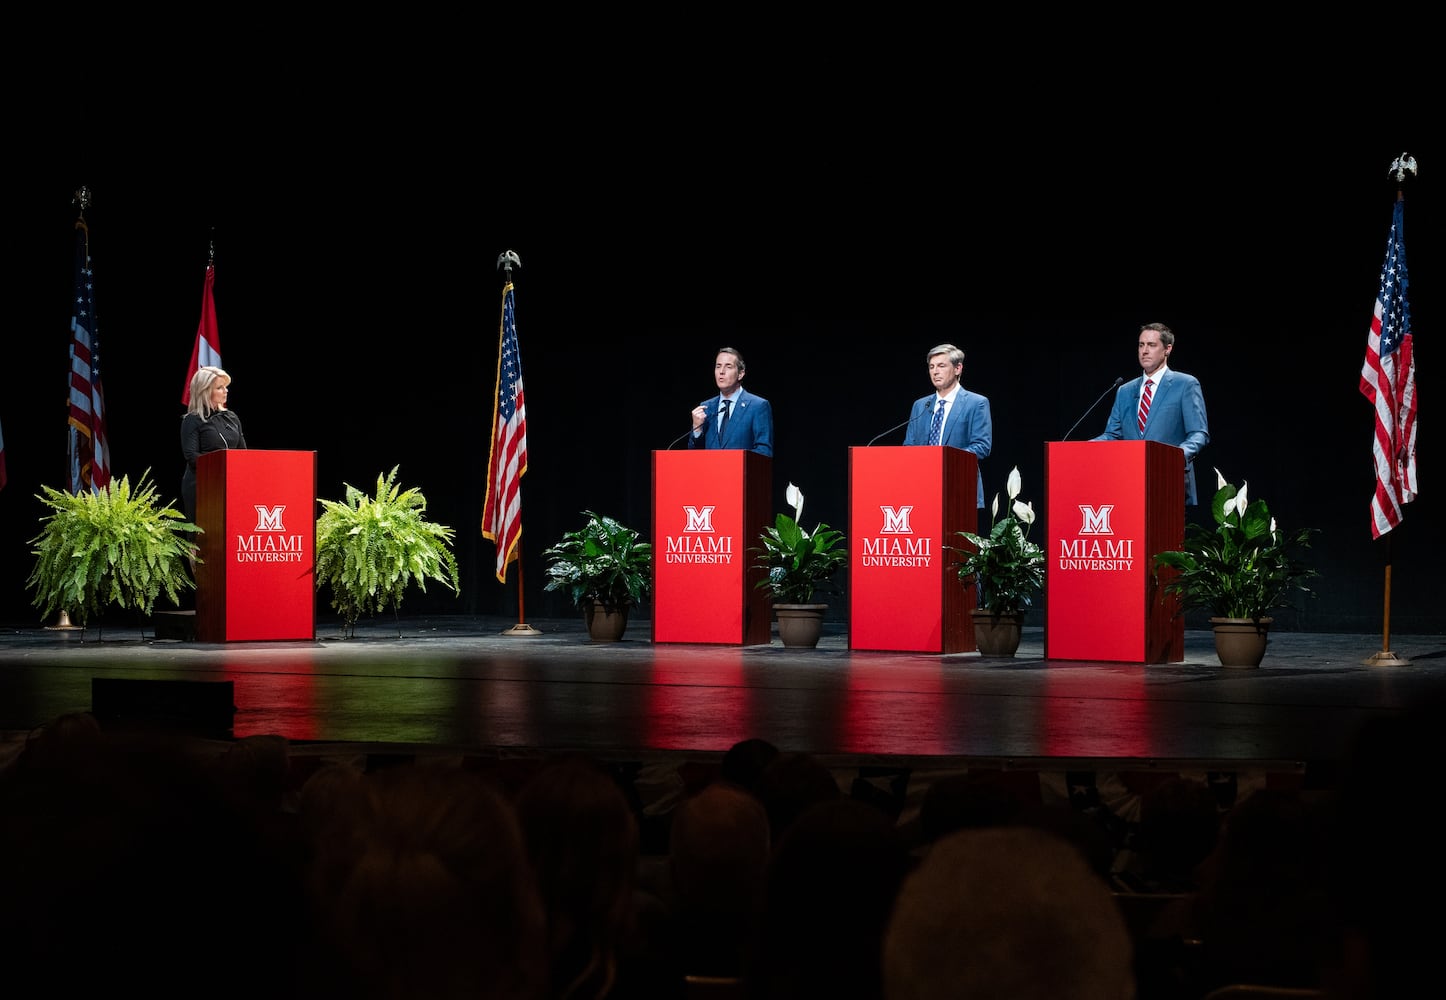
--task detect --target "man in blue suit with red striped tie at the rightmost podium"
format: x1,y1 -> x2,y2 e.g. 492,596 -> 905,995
1090,322 -> 1210,506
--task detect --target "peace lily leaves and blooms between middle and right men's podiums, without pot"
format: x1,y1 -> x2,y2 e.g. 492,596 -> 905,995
947,465 -> 1044,616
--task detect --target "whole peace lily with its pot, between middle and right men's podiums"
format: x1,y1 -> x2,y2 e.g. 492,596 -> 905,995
946,467 -> 1044,656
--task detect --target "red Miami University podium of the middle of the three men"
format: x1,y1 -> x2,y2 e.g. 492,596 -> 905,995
847,445 -> 979,653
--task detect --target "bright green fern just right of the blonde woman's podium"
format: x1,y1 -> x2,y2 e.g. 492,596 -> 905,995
315,465 -> 461,639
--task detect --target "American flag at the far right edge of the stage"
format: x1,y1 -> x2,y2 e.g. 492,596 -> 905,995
1361,197 -> 1416,538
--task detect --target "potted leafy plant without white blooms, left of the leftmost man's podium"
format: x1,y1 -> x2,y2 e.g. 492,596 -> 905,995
542,510 -> 652,642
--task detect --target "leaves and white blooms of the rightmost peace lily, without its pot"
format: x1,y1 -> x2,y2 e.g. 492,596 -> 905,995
1155,470 -> 1317,623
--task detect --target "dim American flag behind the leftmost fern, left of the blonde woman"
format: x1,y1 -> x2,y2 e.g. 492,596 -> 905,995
68,220 -> 110,494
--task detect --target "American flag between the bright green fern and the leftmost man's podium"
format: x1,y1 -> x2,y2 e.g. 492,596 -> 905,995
482,282 -> 528,582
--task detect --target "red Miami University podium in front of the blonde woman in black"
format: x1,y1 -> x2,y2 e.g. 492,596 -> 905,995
195,449 -> 317,643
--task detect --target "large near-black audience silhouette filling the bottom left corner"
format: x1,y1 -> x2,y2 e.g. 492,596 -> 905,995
0,712 -> 307,997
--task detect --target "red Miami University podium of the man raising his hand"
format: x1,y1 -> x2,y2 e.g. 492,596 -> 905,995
652,448 -> 774,646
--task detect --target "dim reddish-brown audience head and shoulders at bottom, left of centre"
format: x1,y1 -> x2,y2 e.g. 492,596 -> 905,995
304,763 -> 547,1000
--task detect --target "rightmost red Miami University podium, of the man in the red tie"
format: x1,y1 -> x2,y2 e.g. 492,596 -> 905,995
1044,441 -> 1184,663
